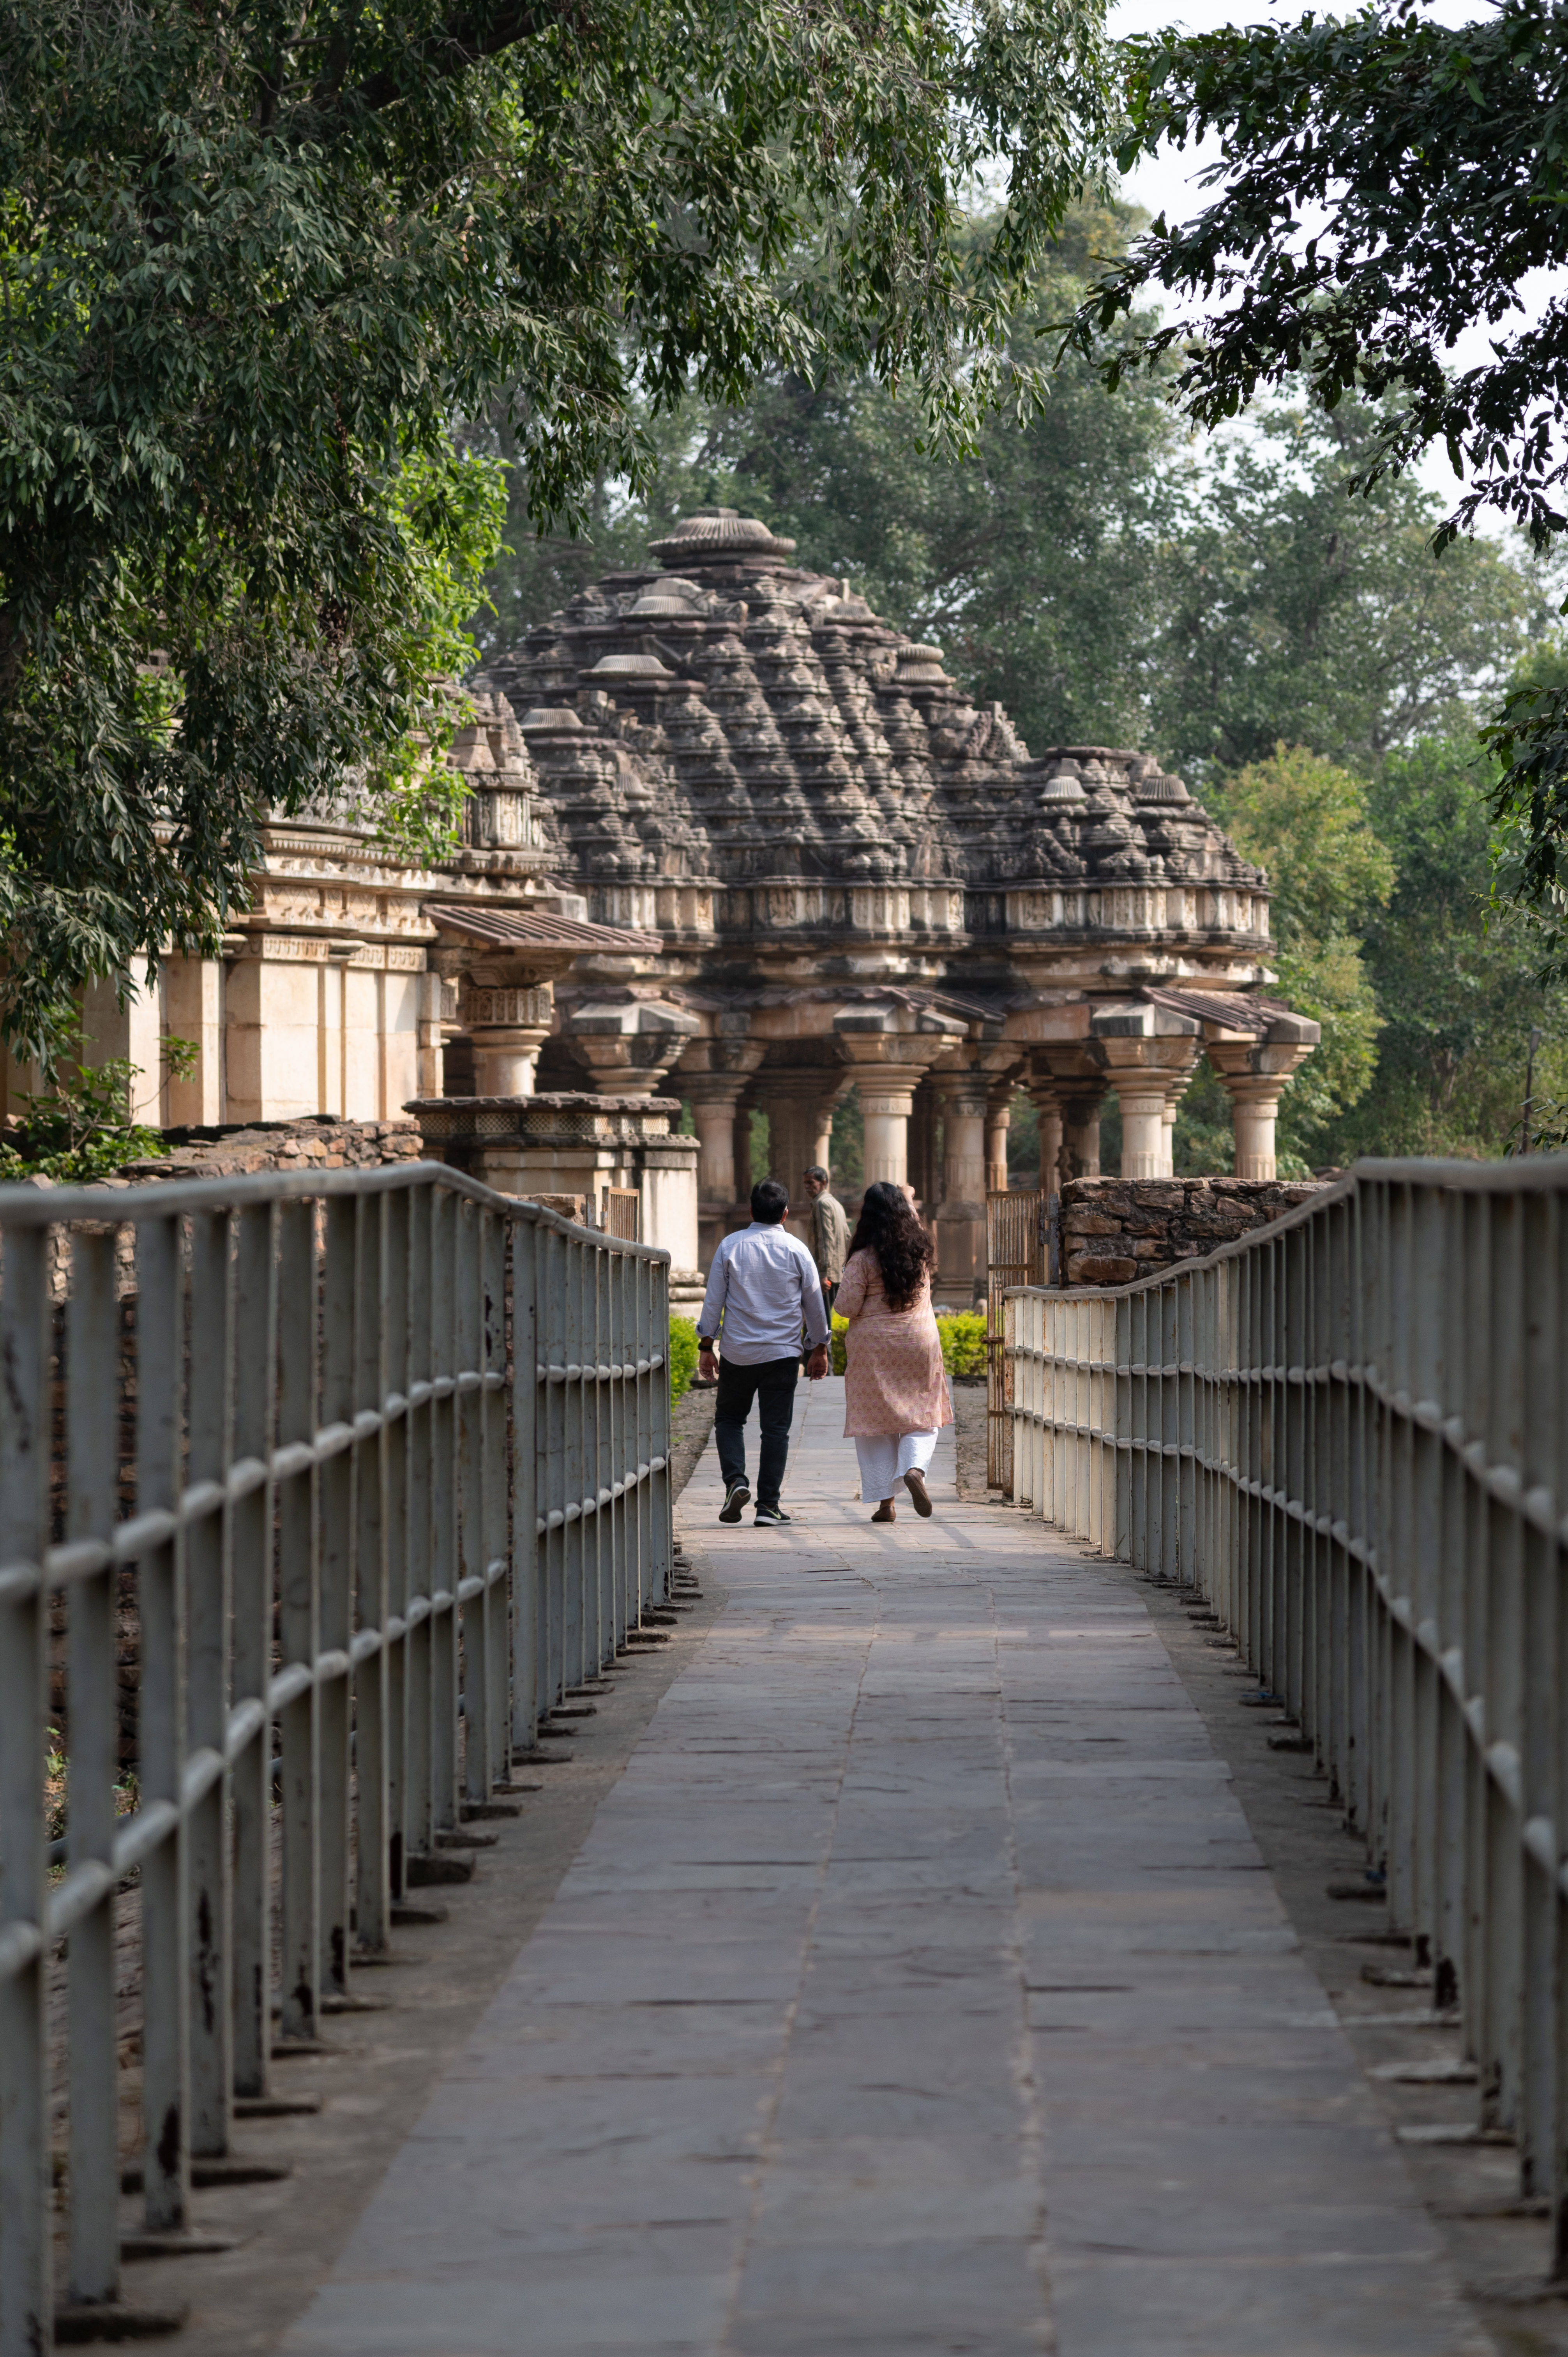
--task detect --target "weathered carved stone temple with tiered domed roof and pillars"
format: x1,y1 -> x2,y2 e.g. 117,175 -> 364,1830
0,509 -> 1318,1301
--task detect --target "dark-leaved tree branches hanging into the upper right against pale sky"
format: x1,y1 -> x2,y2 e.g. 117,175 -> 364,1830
1068,0 -> 1568,966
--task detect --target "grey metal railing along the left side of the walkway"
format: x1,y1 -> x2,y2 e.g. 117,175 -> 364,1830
0,1164 -> 672,2357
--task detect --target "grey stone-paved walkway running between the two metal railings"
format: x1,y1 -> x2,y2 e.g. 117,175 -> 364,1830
288,1381 -> 1492,2357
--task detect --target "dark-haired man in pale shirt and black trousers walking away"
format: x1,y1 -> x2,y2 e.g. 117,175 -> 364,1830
698,1178 -> 828,1525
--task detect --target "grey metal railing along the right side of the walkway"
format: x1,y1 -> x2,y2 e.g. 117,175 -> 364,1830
1007,1157 -> 1568,2272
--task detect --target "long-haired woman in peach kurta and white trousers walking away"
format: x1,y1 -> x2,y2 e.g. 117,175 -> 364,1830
832,1178 -> 953,1523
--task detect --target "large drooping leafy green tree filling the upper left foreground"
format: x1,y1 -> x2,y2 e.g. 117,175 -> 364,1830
0,0 -> 1101,1051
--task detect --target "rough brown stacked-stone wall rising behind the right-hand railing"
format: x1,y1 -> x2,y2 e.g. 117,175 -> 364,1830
1061,1178 -> 1325,1285
